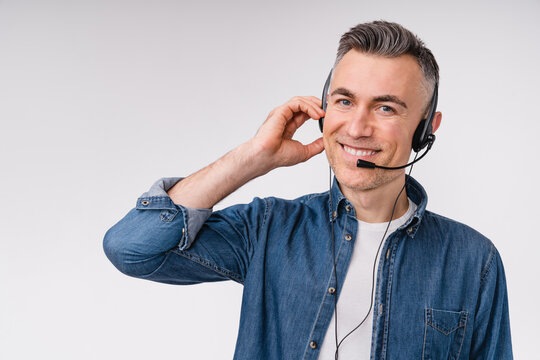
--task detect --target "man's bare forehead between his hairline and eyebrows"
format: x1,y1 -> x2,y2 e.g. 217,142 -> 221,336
330,50 -> 427,104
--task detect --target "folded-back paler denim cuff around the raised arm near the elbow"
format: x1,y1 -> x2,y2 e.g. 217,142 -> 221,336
137,177 -> 212,250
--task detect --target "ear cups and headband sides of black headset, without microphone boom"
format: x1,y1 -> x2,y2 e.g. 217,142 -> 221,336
319,70 -> 439,152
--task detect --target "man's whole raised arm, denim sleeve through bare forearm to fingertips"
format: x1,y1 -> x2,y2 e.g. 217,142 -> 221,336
103,97 -> 324,284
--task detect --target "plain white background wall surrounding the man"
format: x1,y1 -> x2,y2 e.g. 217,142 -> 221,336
0,0 -> 540,359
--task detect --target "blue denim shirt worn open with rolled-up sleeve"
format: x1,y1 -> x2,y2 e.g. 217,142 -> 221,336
104,177 -> 512,360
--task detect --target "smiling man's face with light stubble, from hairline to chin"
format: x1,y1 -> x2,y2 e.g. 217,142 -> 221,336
323,50 -> 431,194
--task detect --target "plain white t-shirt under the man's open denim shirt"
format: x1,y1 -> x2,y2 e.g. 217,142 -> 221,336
319,199 -> 416,360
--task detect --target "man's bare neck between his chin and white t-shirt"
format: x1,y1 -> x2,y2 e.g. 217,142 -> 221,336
340,174 -> 409,223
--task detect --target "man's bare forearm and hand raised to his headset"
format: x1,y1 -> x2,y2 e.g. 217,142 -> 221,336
168,96 -> 324,208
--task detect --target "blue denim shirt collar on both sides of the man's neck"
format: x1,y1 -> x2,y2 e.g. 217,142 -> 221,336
328,175 -> 428,237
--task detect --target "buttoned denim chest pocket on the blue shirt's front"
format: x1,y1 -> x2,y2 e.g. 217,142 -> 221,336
422,308 -> 468,360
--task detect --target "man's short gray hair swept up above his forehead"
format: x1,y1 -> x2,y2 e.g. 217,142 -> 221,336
334,20 -> 439,92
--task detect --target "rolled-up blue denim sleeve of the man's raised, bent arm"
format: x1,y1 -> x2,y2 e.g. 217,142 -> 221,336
103,178 -> 264,285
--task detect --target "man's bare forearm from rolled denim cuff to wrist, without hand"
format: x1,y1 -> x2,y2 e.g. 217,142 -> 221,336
167,142 -> 271,209
